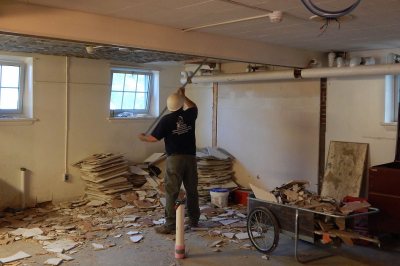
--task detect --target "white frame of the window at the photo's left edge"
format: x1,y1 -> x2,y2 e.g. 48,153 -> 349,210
0,59 -> 26,116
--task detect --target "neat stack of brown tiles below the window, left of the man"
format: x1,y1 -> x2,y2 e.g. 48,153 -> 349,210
73,153 -> 133,201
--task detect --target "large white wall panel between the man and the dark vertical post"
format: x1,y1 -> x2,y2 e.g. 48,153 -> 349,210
209,62 -> 319,191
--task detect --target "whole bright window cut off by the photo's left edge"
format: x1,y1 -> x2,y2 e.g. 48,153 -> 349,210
0,60 -> 25,118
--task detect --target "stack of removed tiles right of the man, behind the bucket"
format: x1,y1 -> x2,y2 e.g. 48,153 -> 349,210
196,147 -> 238,204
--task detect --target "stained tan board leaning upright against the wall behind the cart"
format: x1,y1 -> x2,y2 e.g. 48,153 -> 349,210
321,141 -> 368,201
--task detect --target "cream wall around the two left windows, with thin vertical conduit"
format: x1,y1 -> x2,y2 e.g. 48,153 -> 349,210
0,55 -> 182,209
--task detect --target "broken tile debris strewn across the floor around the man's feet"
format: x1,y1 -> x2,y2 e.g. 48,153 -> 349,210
0,193 -> 248,265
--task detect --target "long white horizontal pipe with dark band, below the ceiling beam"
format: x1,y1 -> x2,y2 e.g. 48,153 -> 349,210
188,64 -> 400,83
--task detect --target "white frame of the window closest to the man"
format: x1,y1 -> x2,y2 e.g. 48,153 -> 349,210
108,66 -> 155,119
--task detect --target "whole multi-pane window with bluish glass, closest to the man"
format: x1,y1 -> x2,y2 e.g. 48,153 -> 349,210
110,67 -> 158,118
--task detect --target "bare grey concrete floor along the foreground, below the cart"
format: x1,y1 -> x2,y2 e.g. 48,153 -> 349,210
0,228 -> 400,266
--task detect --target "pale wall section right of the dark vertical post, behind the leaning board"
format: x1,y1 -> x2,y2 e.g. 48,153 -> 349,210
326,49 -> 400,165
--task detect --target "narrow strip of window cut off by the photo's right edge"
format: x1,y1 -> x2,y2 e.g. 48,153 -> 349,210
384,75 -> 400,124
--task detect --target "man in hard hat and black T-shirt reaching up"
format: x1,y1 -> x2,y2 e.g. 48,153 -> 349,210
139,88 -> 200,234
